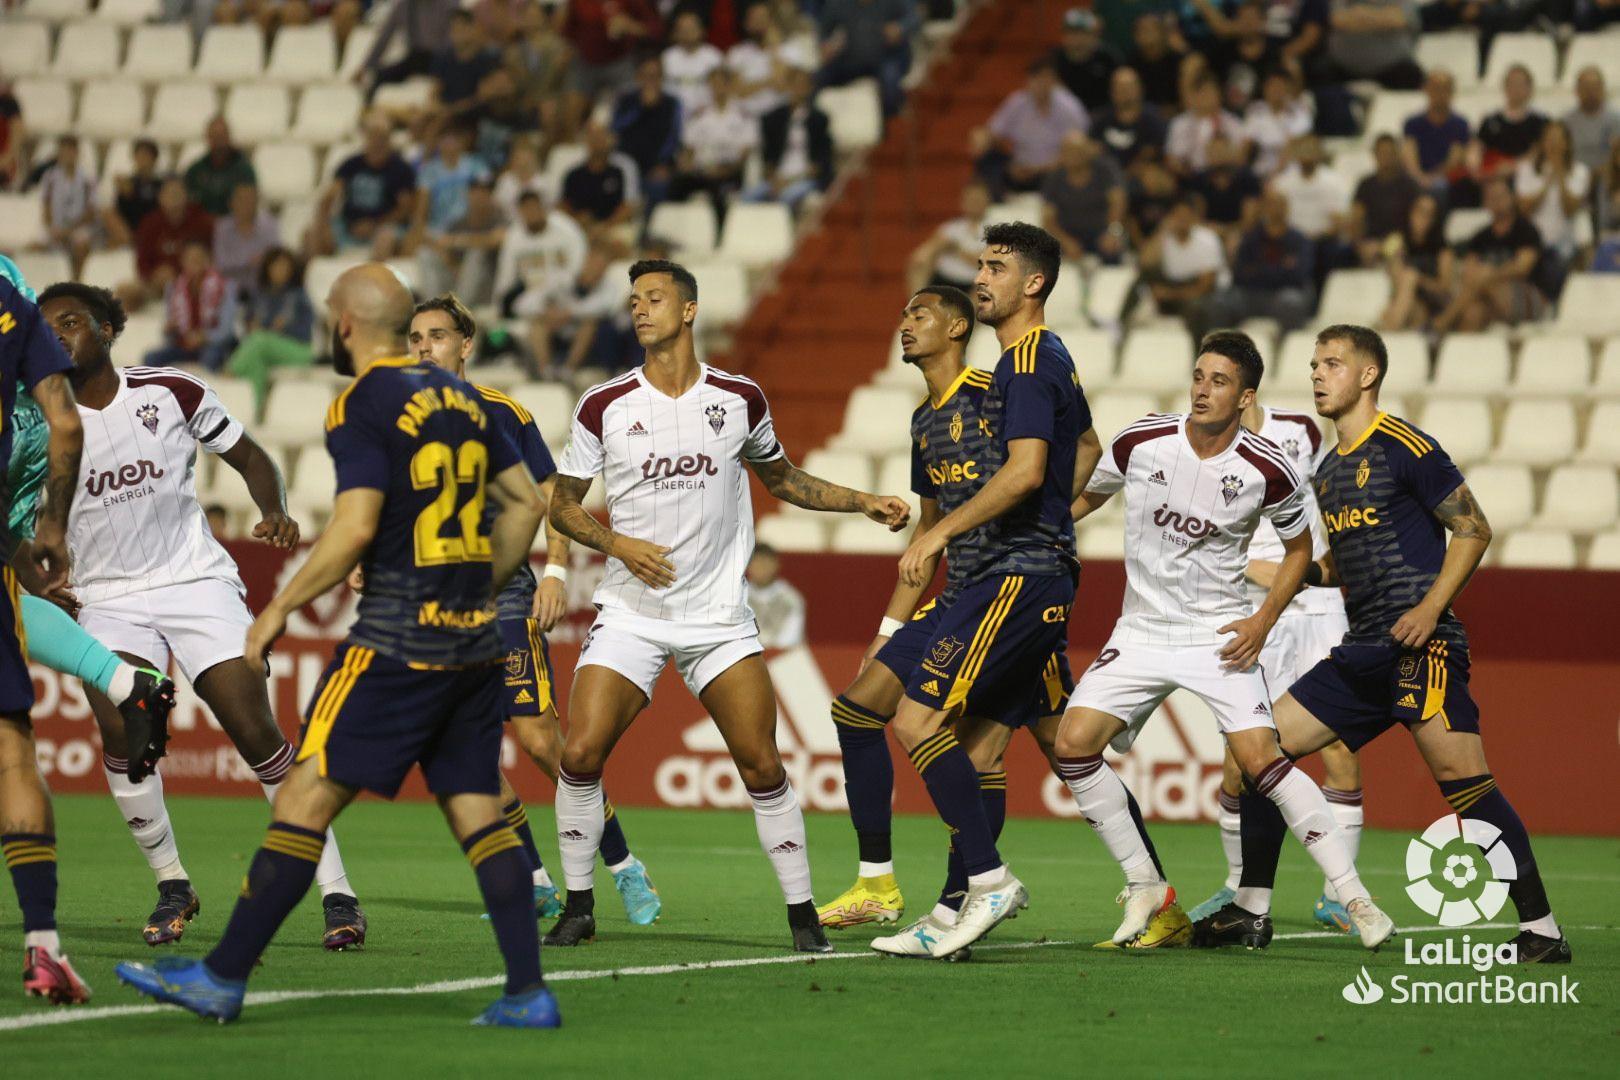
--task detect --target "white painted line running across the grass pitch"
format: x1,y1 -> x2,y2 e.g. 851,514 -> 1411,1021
0,923 -> 1617,1031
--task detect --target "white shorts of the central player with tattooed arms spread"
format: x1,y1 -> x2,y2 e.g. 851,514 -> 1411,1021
575,607 -> 765,701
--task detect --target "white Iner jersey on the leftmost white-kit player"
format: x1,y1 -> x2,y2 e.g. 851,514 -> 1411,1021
68,368 -> 241,604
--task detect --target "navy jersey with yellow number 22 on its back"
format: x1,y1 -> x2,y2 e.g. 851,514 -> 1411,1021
326,358 -> 523,667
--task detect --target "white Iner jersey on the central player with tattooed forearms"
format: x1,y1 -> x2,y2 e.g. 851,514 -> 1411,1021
557,364 -> 782,625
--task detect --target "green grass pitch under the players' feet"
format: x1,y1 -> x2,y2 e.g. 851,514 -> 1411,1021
0,797 -> 1620,1080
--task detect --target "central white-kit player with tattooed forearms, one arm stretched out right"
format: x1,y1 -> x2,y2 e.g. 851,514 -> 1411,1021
546,261 -> 910,952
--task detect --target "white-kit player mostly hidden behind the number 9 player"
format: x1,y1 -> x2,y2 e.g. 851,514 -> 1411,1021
1187,403 -> 1361,934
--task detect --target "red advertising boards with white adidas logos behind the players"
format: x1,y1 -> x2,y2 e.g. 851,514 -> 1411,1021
31,544 -> 1620,836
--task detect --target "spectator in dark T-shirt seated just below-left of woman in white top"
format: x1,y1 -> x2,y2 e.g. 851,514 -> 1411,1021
1434,176 -> 1541,334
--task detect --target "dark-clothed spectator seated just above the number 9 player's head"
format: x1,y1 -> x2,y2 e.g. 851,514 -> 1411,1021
1215,189 -> 1315,332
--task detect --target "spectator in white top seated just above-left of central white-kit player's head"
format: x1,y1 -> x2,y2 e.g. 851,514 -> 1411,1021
496,191 -> 586,377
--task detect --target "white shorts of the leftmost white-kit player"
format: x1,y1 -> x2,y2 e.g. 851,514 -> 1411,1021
79,578 -> 253,683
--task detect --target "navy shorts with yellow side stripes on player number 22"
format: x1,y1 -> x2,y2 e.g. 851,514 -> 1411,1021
298,641 -> 505,798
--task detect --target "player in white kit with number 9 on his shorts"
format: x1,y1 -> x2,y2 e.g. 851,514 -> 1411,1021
1058,330 -> 1395,949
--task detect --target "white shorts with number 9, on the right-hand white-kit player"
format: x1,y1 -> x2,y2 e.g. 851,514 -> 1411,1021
1069,640 -> 1275,753
